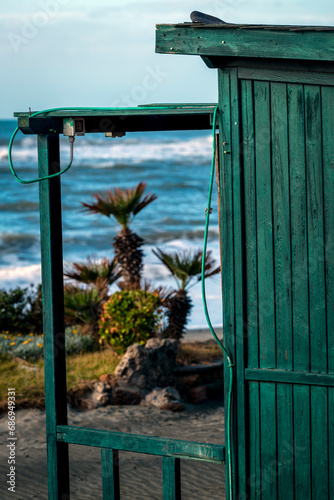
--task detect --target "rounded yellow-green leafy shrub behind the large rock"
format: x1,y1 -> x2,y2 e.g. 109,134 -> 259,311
99,290 -> 162,355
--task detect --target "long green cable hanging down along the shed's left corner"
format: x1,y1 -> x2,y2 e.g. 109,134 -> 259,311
201,106 -> 234,500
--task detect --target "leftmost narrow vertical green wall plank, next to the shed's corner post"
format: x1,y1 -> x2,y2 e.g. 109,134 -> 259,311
240,80 -> 261,500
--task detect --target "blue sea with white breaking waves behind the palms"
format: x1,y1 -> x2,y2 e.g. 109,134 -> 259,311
0,120 -> 222,328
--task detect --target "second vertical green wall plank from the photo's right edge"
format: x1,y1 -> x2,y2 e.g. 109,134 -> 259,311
305,85 -> 328,500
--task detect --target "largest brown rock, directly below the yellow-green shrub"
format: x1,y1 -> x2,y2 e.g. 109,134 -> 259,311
115,338 -> 177,389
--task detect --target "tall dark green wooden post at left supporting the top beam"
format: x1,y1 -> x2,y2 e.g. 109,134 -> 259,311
38,135 -> 70,500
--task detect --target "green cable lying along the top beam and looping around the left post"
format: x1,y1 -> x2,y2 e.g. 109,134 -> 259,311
8,105 -> 189,184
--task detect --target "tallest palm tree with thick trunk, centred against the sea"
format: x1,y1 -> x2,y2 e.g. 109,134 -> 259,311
82,182 -> 156,290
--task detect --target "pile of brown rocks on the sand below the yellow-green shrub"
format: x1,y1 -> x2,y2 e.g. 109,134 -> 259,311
71,338 -> 223,411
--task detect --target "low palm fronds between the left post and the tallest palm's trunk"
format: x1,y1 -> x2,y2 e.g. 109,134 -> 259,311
64,257 -> 121,285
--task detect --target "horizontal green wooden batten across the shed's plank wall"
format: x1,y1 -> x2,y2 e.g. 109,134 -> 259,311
245,368 -> 334,387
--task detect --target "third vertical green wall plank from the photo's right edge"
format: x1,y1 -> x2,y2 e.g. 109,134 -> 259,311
288,84 -> 311,500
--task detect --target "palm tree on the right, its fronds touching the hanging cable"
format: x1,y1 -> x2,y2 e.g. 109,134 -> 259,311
152,248 -> 220,340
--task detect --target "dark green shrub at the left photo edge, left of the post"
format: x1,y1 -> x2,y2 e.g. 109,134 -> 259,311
0,285 -> 43,334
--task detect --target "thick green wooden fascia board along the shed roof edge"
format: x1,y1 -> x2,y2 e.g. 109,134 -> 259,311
155,24 -> 334,61
